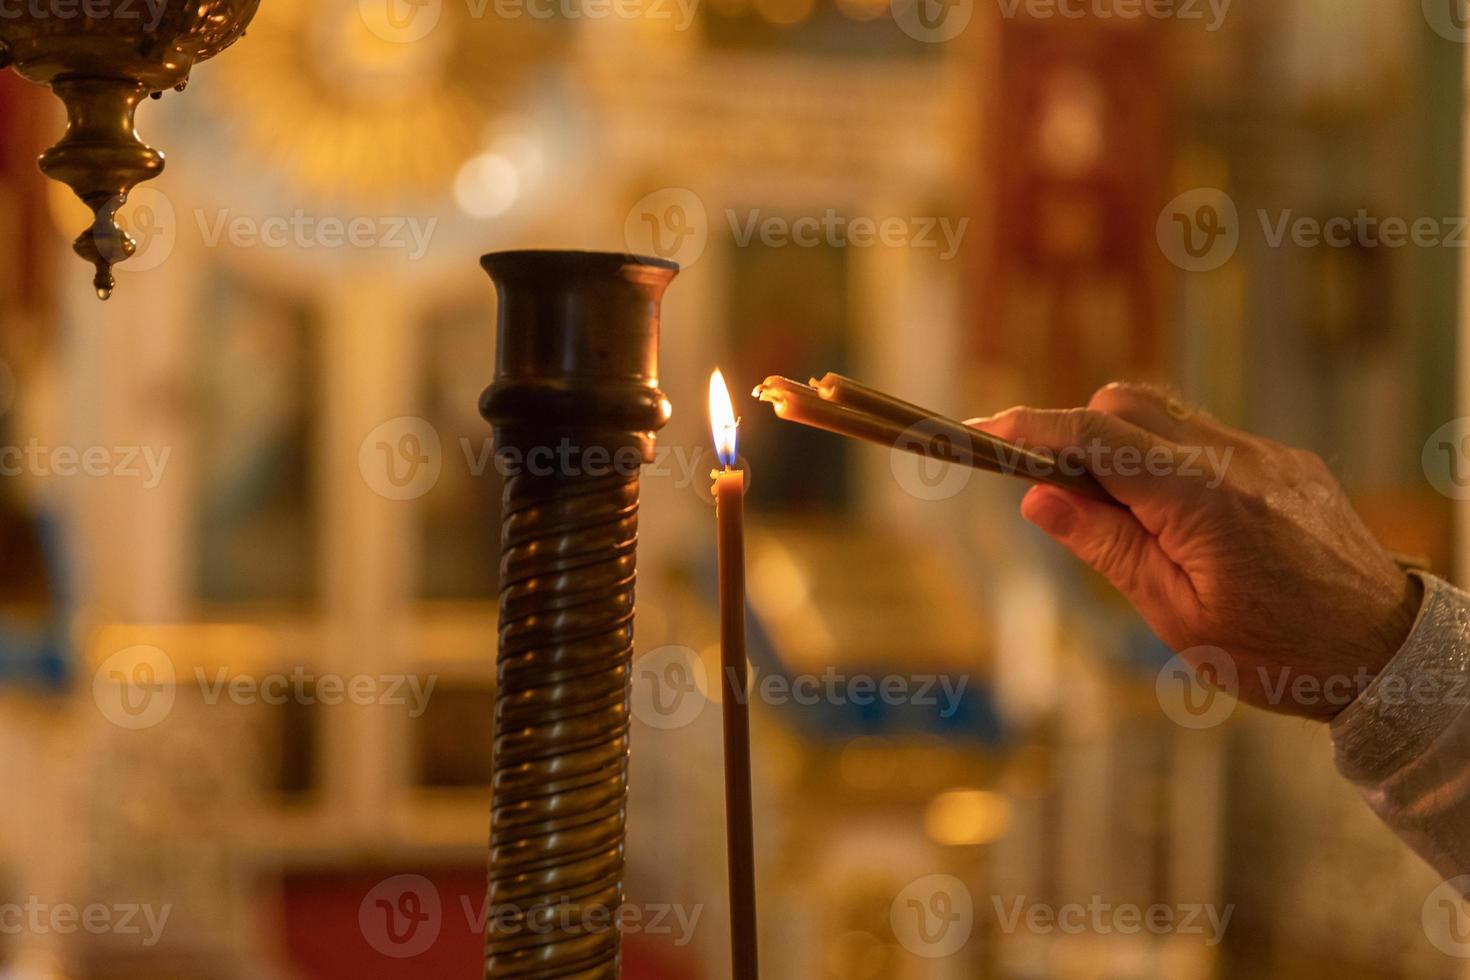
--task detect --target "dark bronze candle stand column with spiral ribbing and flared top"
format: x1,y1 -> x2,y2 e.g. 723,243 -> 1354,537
481,251 -> 678,980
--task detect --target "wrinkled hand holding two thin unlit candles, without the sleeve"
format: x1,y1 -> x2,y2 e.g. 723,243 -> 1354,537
972,385 -> 1421,720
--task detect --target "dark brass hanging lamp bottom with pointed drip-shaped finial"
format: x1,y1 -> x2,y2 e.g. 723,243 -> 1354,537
0,0 -> 260,300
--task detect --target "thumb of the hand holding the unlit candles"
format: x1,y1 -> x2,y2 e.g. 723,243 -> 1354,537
1020,486 -> 1194,620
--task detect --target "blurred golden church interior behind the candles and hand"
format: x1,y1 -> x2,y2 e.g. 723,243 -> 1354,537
0,0 -> 1467,980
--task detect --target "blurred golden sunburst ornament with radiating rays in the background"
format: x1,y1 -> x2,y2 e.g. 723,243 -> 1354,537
207,0 -> 570,208
